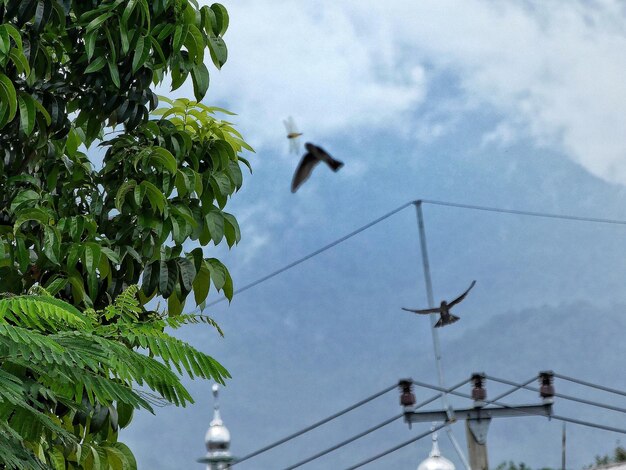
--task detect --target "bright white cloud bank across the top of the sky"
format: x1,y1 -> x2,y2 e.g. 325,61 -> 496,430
185,0 -> 626,183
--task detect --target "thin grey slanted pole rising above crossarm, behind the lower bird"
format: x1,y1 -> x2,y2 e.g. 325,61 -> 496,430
415,201 -> 472,470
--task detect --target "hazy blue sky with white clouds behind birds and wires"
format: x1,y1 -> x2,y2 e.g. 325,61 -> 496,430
121,0 -> 626,470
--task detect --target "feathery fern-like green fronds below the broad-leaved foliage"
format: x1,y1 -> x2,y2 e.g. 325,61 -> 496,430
0,286 -> 228,468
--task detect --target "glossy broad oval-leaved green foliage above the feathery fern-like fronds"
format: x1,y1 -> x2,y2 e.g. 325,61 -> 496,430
0,0 -> 249,314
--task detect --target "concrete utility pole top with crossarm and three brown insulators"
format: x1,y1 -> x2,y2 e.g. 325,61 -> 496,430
398,372 -> 554,470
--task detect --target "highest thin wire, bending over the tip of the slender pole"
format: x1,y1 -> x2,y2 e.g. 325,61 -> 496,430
197,199 -> 626,313
